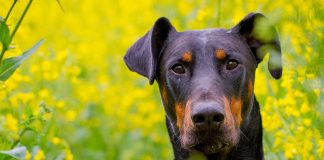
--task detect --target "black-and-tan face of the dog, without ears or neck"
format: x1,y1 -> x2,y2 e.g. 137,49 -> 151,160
157,29 -> 257,153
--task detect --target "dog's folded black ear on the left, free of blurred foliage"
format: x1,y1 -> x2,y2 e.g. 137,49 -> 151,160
124,17 -> 175,84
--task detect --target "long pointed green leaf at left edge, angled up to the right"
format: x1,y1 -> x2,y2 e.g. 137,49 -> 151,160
0,39 -> 44,81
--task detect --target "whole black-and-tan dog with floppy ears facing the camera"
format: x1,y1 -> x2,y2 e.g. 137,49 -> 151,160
124,13 -> 282,160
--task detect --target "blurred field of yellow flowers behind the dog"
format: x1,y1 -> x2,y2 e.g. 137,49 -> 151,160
0,0 -> 324,160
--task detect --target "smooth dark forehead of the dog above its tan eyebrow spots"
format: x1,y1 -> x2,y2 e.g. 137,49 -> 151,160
165,29 -> 249,56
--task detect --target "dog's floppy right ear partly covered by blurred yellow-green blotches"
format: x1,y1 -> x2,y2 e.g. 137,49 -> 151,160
231,13 -> 282,79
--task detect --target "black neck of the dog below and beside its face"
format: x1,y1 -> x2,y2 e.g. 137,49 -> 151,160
166,97 -> 263,160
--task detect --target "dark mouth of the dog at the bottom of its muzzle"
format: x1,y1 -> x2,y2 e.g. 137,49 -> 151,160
190,142 -> 230,154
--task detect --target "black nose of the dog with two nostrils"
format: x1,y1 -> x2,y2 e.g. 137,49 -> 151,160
191,103 -> 224,127
